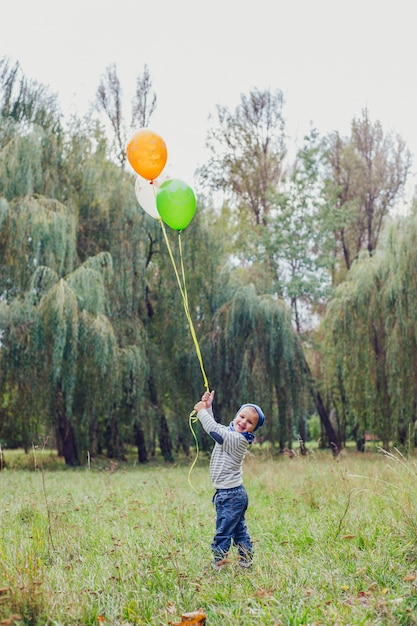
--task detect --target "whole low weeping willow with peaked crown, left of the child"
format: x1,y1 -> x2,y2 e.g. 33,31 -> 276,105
39,253 -> 147,465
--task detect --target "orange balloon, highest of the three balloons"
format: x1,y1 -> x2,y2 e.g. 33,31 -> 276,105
126,128 -> 168,180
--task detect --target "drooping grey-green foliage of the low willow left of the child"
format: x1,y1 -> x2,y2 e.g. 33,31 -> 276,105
33,253 -> 146,453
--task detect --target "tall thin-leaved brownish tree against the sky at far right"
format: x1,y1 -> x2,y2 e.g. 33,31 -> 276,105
327,110 -> 411,277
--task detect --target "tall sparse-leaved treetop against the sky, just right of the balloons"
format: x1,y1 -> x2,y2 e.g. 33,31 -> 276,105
199,89 -> 286,226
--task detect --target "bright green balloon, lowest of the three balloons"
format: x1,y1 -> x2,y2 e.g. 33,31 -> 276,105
156,178 -> 197,230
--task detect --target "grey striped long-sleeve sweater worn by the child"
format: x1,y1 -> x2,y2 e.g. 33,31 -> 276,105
197,408 -> 249,489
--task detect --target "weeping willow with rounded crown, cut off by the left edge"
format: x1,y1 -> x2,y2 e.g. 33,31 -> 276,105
0,196 -> 76,450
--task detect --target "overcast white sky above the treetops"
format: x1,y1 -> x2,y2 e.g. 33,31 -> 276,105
0,0 -> 417,199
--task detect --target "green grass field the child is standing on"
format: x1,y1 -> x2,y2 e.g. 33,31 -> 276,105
0,451 -> 417,626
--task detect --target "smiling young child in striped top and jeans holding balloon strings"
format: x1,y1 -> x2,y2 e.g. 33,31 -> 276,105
194,391 -> 265,569
